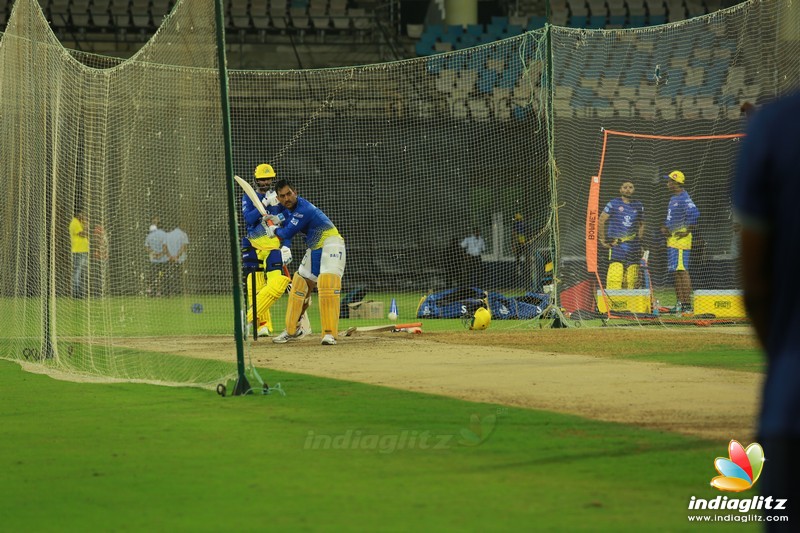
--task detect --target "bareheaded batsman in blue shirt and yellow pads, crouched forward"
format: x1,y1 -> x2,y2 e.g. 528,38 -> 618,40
268,179 -> 347,345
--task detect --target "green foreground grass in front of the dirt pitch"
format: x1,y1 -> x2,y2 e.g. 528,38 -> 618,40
0,361 -> 764,531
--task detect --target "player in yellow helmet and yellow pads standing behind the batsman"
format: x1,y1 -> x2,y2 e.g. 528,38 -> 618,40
242,163 -> 310,338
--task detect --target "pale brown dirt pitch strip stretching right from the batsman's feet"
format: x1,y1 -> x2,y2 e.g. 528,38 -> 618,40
125,328 -> 763,441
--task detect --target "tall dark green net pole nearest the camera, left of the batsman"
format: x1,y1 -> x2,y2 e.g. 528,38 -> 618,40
214,0 -> 250,396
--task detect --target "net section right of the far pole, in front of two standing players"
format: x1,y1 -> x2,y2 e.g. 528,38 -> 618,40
551,1 -> 800,325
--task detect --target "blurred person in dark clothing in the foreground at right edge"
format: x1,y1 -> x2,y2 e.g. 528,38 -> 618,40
733,93 -> 800,531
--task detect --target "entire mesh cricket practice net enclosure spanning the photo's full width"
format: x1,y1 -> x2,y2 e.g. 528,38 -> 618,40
0,0 -> 800,384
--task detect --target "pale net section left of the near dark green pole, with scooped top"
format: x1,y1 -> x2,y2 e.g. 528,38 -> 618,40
0,0 -> 235,384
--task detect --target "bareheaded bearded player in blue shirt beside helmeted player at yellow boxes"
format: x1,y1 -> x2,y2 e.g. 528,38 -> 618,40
598,181 -> 644,289
